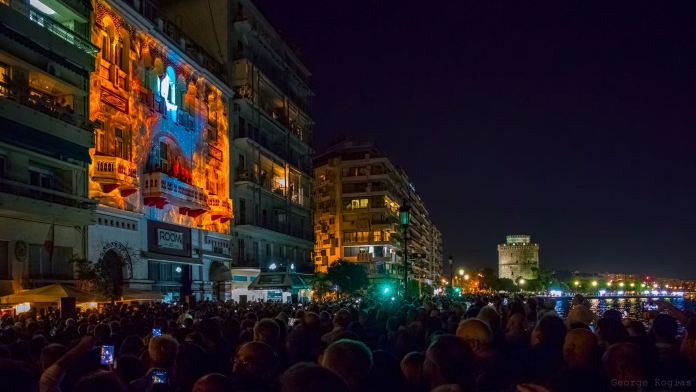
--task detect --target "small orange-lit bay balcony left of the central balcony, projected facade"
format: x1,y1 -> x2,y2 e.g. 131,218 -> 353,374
92,155 -> 138,197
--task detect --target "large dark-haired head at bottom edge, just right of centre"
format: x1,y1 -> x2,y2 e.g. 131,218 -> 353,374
423,335 -> 475,389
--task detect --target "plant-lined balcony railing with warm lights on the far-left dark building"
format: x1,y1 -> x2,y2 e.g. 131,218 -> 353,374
0,81 -> 94,132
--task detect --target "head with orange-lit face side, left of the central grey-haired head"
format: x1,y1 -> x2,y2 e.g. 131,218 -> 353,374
232,342 -> 278,383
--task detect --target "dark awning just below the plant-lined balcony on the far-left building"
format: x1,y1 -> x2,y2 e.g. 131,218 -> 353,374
0,117 -> 92,163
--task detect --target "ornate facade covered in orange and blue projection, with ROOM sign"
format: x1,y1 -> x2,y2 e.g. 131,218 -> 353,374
89,0 -> 233,299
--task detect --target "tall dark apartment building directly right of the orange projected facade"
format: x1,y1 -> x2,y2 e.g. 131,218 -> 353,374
155,0 -> 314,272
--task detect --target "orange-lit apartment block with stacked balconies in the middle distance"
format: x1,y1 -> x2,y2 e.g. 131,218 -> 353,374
314,141 -> 442,290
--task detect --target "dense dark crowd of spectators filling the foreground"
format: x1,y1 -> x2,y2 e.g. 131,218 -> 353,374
0,296 -> 696,392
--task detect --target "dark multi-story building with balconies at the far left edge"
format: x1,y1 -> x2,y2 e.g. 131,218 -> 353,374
0,0 -> 98,294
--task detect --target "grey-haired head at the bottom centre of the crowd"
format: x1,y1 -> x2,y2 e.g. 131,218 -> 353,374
321,339 -> 373,390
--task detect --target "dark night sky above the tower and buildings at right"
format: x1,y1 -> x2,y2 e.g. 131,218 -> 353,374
258,0 -> 696,278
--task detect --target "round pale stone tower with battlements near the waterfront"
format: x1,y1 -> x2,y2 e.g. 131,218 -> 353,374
498,235 -> 539,280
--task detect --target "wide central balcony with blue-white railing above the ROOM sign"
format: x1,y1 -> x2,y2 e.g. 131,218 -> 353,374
143,172 -> 208,218
